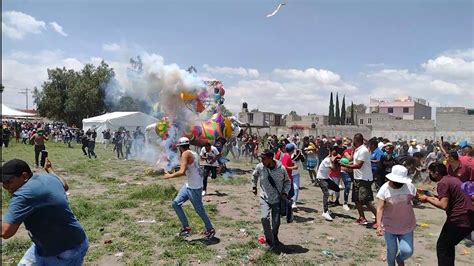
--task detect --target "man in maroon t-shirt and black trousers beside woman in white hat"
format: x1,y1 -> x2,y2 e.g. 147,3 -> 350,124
418,163 -> 474,266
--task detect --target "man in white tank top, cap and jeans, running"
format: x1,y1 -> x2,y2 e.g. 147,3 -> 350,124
165,137 -> 216,239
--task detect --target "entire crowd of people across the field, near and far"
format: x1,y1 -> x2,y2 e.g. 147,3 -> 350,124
2,119 -> 474,265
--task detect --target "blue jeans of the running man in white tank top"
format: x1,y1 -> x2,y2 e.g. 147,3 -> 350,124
172,185 -> 213,230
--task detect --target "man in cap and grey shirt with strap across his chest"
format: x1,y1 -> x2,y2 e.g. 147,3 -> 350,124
252,150 -> 291,250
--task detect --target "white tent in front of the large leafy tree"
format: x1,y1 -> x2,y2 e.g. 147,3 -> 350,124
82,112 -> 158,142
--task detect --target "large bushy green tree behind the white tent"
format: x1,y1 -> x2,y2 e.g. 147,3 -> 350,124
33,61 -> 115,126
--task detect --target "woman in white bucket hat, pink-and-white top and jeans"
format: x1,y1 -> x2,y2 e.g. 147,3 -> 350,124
376,165 -> 416,266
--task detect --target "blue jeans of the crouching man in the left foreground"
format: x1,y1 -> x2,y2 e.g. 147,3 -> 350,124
18,238 -> 89,266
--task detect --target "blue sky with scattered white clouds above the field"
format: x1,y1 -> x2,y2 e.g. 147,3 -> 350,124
2,0 -> 474,113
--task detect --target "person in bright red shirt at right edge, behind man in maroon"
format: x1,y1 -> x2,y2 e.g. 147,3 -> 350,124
447,151 -> 474,182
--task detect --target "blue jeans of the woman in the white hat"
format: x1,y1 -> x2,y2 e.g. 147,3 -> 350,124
384,232 -> 413,266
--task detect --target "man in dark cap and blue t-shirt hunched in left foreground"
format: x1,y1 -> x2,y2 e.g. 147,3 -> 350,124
1,159 -> 89,265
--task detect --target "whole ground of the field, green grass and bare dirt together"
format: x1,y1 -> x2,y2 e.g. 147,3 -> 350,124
1,140 -> 474,265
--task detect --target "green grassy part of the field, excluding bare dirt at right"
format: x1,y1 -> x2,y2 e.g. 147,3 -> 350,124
2,140 -> 286,265
